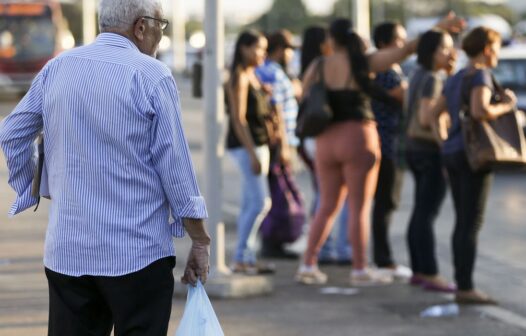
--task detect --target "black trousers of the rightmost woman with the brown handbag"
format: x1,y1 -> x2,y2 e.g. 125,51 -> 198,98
444,151 -> 493,290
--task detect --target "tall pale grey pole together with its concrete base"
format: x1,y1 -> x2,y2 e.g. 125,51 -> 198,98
175,0 -> 273,298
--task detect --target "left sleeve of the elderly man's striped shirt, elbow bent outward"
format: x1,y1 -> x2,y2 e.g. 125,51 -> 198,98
0,68 -> 46,216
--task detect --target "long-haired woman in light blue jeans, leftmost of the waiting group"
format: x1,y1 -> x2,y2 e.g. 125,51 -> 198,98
227,31 -> 273,274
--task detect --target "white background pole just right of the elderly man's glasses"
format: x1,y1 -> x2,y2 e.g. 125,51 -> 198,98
171,0 -> 186,71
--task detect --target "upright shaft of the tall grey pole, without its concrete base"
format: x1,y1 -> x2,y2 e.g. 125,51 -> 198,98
203,0 -> 229,275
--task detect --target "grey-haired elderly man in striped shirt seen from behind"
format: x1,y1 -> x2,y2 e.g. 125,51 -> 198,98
0,0 -> 210,336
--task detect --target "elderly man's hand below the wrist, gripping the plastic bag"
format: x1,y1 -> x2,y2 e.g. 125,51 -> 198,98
181,242 -> 210,287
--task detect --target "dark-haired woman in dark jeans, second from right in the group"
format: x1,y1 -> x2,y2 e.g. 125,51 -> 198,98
406,30 -> 456,292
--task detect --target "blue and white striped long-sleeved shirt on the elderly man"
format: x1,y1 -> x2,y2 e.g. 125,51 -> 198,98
0,33 -> 207,276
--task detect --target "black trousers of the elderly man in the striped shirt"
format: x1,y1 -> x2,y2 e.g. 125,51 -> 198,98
45,257 -> 175,336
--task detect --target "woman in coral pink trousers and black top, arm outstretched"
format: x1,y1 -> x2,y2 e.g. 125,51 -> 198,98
296,14 -> 466,286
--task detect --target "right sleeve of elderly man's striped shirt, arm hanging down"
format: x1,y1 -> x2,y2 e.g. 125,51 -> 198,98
150,77 -> 208,230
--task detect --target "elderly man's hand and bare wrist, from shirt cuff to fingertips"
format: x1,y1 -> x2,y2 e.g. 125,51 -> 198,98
181,218 -> 210,287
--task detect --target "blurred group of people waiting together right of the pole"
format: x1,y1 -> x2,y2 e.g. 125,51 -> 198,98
226,13 -> 516,304
